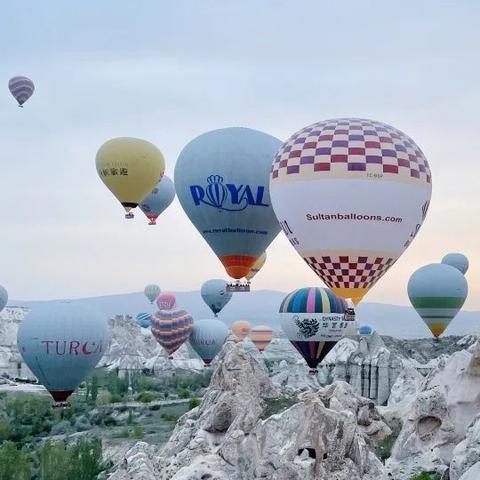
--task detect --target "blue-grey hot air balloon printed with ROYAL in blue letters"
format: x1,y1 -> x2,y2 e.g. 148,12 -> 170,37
175,127 -> 281,279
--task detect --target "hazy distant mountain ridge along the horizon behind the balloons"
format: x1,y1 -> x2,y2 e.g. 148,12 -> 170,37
9,290 -> 480,338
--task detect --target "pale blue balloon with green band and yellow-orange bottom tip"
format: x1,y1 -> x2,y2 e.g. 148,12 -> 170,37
408,263 -> 468,339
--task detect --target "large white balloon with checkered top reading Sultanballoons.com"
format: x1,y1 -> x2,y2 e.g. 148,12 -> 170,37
270,118 -> 432,304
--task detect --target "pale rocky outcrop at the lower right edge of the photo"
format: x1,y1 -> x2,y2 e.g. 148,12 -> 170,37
387,347 -> 480,480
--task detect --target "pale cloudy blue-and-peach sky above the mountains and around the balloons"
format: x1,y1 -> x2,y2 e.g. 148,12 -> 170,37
0,0 -> 480,310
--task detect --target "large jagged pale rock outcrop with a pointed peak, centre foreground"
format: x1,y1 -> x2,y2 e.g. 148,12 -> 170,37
112,339 -> 390,480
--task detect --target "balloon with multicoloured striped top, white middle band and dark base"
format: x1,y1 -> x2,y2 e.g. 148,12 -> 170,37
280,287 -> 350,373
